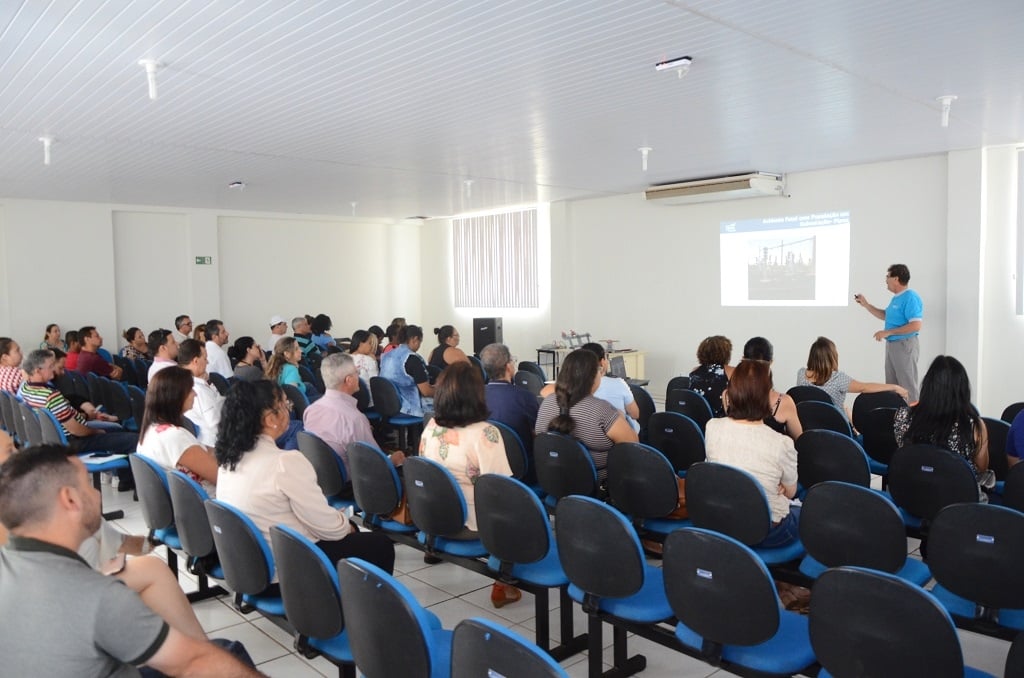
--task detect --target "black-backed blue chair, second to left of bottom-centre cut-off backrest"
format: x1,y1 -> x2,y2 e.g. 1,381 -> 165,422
270,525 -> 355,678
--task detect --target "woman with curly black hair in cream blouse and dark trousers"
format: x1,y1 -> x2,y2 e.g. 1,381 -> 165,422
217,381 -> 394,574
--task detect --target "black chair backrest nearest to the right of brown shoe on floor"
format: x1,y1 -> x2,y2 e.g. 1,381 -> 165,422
555,496 -> 645,609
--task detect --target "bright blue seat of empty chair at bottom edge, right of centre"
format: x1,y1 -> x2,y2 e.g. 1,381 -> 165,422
676,609 -> 816,674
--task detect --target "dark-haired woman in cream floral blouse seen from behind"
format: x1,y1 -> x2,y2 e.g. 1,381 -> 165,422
420,362 -> 522,607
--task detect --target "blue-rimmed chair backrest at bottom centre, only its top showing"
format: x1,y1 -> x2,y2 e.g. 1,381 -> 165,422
452,618 -> 568,678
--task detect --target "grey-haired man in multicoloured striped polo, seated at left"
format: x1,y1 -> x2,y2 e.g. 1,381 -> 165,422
18,348 -> 138,492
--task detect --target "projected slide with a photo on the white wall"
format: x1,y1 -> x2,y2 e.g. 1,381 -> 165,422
719,211 -> 850,306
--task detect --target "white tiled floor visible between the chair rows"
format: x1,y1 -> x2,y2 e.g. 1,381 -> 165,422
103,485 -> 1009,678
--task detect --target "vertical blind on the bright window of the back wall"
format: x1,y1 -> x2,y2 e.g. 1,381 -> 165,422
452,209 -> 540,308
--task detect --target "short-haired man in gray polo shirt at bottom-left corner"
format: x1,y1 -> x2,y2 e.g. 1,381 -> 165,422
0,446 -> 260,678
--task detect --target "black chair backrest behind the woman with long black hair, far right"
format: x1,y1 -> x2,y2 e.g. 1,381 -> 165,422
889,444 -> 978,520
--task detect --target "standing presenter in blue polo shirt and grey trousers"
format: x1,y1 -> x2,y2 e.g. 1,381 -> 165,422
853,263 -> 925,402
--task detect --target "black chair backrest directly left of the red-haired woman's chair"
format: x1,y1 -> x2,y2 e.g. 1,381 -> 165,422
608,442 -> 679,520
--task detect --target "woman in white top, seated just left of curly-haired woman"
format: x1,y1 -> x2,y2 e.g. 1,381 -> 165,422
138,366 -> 217,495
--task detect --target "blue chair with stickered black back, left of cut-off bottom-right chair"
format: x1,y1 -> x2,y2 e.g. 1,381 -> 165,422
663,527 -> 814,674
